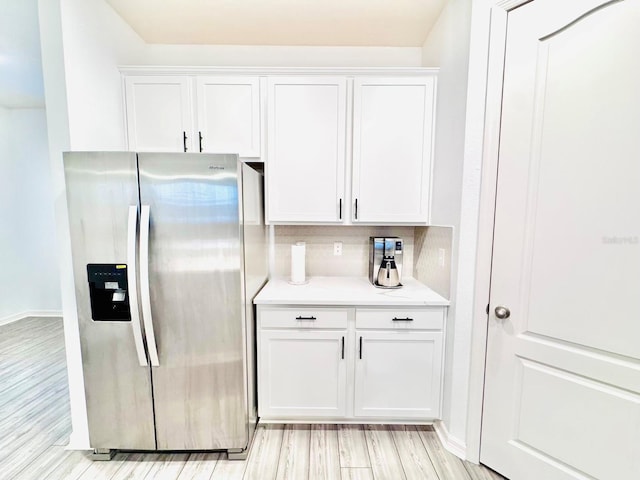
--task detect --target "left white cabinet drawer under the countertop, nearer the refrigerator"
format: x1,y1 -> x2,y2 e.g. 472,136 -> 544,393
259,307 -> 349,329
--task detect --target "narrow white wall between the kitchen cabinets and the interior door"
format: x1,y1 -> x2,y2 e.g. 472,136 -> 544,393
422,0 -> 475,454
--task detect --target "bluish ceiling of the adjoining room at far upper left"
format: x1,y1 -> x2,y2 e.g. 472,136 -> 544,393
0,0 -> 44,108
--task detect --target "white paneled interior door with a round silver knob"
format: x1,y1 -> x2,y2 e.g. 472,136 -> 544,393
480,0 -> 640,480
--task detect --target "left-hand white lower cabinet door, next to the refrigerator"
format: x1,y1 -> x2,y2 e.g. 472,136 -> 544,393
258,330 -> 347,419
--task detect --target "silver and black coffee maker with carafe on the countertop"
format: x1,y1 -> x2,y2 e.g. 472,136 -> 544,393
369,237 -> 403,288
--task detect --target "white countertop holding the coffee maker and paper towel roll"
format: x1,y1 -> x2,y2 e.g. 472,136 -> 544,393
253,277 -> 449,306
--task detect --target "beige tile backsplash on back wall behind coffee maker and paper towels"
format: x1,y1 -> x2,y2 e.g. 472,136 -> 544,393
273,225 -> 415,277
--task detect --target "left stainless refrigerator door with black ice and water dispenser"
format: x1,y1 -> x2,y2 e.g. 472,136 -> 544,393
64,152 -> 156,450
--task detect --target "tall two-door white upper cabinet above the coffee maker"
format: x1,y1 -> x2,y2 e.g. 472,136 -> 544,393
267,76 -> 436,224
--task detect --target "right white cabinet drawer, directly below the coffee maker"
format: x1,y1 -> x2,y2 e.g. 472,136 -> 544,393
356,307 -> 444,330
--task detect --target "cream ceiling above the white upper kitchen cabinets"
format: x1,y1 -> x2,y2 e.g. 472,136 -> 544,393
106,0 -> 446,47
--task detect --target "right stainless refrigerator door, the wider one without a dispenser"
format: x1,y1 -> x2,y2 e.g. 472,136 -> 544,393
138,153 -> 248,450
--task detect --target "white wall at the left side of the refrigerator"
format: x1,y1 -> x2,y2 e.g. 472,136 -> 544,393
38,0 -> 148,449
